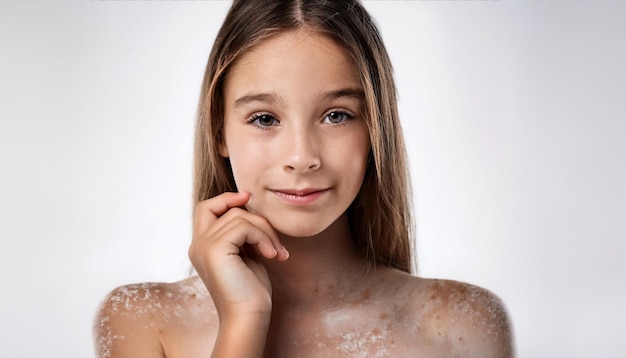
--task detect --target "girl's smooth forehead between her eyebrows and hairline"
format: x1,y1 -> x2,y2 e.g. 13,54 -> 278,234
225,29 -> 361,97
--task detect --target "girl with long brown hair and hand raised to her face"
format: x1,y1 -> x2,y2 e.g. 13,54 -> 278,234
95,0 -> 513,358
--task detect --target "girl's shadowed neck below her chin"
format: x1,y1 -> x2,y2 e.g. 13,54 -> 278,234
265,215 -> 367,311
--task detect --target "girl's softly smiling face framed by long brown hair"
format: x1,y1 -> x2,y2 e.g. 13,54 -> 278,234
220,30 -> 370,237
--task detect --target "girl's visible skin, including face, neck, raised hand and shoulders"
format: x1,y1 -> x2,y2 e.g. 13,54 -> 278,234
95,30 -> 513,358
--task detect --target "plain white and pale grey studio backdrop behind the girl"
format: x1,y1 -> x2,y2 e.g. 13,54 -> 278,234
0,0 -> 626,357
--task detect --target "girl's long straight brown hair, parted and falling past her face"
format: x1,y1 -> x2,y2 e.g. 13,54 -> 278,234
193,0 -> 414,272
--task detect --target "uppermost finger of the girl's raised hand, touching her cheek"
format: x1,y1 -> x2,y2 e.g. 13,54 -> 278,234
193,192 -> 250,233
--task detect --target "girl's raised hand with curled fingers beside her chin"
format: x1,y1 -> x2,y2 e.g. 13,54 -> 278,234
189,193 -> 289,324
